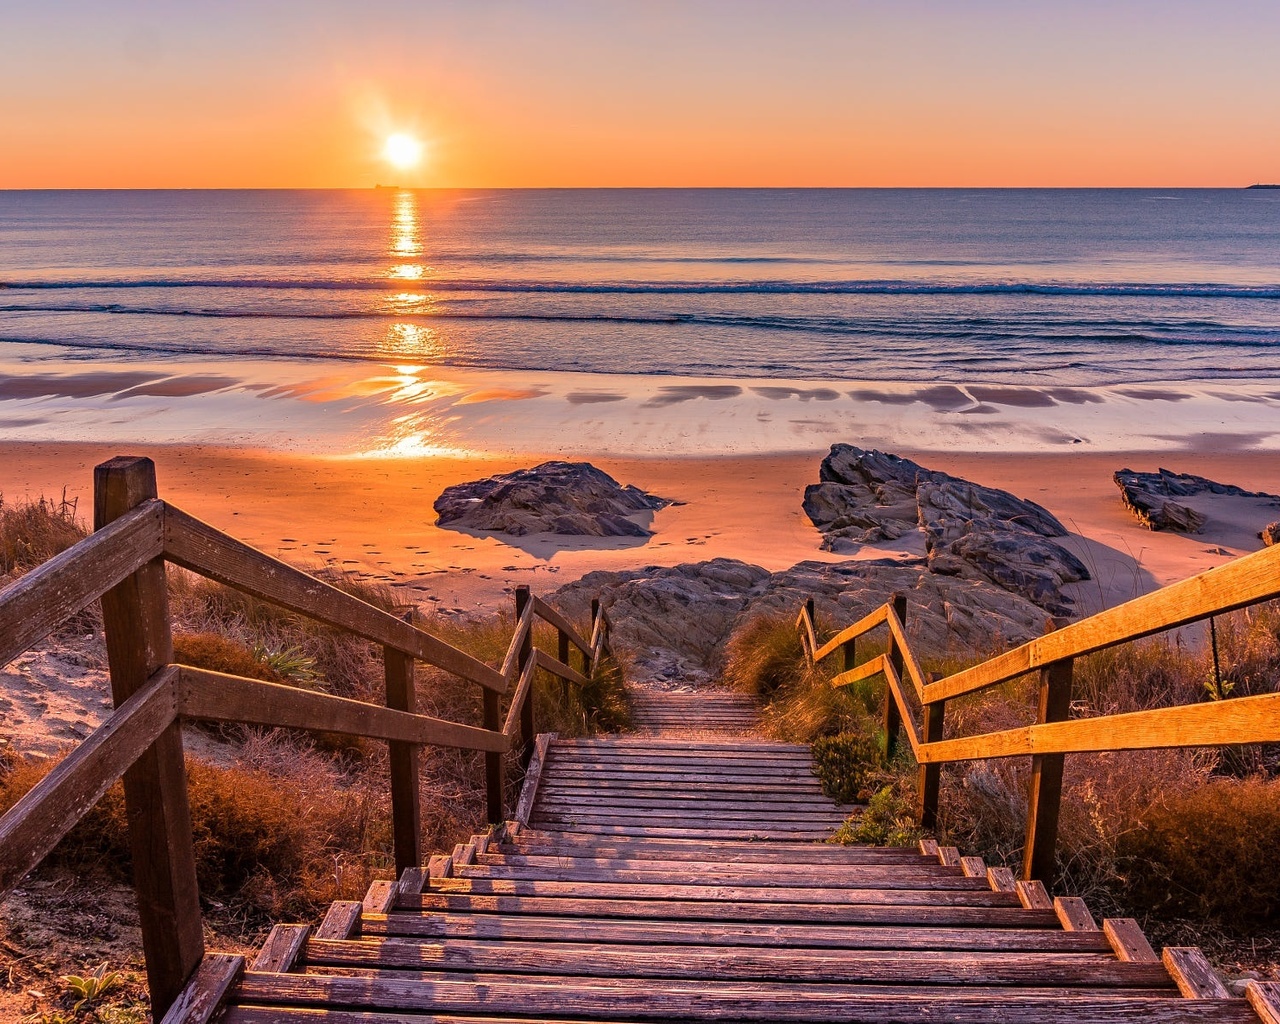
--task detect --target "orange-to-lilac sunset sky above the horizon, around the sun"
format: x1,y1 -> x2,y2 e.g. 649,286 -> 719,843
0,0 -> 1280,188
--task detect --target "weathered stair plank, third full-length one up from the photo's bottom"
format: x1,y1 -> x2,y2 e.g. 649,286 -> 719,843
363,909 -> 1112,955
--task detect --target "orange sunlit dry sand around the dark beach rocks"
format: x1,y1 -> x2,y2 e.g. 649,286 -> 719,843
0,438 -> 1280,616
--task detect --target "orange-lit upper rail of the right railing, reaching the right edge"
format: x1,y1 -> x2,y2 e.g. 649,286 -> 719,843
924,548 -> 1280,704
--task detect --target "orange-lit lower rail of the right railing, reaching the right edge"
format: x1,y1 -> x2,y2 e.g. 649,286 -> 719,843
919,694 -> 1280,762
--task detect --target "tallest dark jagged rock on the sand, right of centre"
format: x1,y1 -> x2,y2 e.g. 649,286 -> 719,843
804,444 -> 1089,616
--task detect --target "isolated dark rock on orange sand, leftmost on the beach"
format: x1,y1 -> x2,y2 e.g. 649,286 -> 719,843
434,462 -> 671,536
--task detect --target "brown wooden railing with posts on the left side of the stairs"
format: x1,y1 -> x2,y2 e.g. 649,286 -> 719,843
0,457 -> 609,1020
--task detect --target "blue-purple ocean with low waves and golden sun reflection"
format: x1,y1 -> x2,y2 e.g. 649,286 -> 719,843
0,188 -> 1280,387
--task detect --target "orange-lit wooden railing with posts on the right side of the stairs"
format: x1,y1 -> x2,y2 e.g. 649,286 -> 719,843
796,547 -> 1280,879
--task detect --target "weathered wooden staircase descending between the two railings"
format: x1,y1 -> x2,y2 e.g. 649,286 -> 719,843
192,686 -> 1274,1024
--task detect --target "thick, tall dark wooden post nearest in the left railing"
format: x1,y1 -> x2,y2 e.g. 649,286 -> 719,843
93,456 -> 205,1020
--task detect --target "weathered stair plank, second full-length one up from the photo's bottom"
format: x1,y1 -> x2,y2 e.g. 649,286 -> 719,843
306,937 -> 1169,988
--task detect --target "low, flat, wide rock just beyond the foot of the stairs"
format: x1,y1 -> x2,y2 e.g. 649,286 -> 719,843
553,558 -> 1046,682
